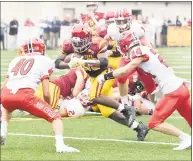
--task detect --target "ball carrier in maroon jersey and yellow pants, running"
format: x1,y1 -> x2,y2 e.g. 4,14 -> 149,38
55,24 -> 148,140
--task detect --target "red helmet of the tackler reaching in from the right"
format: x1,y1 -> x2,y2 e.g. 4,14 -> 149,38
118,31 -> 140,58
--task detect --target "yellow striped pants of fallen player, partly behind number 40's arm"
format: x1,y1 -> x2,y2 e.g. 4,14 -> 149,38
35,82 -> 60,109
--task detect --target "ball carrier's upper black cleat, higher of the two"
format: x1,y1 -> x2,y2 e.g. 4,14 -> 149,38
121,104 -> 136,127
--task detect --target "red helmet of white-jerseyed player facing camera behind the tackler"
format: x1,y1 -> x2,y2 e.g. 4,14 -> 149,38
115,9 -> 132,32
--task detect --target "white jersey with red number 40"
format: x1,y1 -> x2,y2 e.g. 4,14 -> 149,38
6,55 -> 54,93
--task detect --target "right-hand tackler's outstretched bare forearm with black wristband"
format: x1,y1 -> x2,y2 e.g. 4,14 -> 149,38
104,57 -> 147,80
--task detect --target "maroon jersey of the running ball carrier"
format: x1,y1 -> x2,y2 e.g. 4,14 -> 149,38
81,36 -> 108,77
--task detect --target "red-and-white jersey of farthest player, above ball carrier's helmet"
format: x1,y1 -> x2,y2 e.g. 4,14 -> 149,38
81,12 -> 104,27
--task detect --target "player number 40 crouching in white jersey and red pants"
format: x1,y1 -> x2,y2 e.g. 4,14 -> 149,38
1,38 -> 79,152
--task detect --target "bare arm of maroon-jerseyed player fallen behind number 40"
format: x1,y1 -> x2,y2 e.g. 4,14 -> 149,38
72,70 -> 85,97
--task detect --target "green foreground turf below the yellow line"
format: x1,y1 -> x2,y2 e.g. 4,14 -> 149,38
1,117 -> 191,160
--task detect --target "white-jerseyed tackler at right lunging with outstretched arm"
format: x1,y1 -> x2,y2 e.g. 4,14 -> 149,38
98,31 -> 192,150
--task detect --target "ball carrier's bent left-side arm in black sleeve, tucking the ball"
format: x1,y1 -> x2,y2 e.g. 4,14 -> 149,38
54,54 -> 70,69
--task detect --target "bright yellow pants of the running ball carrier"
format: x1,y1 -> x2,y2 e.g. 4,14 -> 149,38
89,68 -> 115,117
